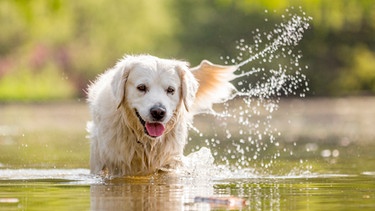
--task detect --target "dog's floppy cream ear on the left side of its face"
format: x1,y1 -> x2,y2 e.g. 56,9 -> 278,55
111,58 -> 132,108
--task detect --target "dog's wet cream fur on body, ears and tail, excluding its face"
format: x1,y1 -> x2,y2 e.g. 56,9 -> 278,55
87,55 -> 235,176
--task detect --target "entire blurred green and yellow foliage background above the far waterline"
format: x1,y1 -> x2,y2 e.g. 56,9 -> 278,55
0,0 -> 375,100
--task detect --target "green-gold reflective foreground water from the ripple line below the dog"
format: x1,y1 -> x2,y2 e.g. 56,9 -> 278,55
0,169 -> 375,210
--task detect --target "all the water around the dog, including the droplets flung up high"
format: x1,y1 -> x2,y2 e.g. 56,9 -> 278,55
0,9 -> 375,210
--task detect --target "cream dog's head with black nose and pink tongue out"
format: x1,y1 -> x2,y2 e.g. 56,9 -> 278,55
112,55 -> 198,138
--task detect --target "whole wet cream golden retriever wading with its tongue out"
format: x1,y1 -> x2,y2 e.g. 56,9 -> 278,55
87,55 -> 236,177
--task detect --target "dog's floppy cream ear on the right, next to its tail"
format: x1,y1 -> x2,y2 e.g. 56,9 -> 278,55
177,63 -> 199,111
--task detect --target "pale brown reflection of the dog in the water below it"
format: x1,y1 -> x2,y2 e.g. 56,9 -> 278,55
90,173 -> 213,210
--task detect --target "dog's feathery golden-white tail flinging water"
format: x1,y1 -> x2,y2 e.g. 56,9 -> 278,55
190,60 -> 238,114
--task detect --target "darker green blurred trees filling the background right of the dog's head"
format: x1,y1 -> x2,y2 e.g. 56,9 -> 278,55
176,0 -> 375,96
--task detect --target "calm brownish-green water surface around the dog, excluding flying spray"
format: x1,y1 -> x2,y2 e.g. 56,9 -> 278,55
0,98 -> 375,210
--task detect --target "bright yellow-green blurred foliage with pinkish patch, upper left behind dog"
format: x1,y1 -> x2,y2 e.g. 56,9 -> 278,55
0,0 -> 177,99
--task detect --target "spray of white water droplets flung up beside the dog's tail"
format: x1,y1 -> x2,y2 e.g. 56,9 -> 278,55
189,9 -> 311,176
